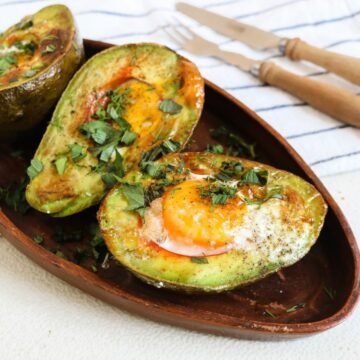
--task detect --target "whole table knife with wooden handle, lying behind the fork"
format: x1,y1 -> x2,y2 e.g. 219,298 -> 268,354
176,2 -> 360,85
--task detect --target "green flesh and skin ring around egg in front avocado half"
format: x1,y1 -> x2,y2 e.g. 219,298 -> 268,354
98,153 -> 327,294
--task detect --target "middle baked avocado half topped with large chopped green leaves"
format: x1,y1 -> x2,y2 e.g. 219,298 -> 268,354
26,43 -> 204,216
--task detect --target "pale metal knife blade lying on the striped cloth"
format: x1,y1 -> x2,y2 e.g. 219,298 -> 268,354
176,2 -> 282,50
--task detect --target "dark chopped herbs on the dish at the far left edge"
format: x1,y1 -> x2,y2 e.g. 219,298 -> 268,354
0,178 -> 29,214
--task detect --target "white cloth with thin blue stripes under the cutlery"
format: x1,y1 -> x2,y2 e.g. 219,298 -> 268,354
0,0 -> 360,177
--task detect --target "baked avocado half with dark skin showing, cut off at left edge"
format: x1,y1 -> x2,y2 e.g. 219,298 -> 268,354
0,5 -> 83,141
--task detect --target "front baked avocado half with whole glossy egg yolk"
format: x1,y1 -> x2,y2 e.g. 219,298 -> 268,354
98,153 -> 327,293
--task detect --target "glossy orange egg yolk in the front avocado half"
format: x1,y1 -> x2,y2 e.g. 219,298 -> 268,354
152,179 -> 246,256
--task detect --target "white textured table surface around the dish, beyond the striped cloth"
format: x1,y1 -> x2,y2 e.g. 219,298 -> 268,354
0,172 -> 360,360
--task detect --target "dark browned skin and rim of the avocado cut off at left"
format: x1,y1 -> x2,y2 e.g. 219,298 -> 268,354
0,5 -> 84,142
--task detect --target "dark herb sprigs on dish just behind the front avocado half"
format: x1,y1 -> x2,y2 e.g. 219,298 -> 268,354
210,126 -> 257,159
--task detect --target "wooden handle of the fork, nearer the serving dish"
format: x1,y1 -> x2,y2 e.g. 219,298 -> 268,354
259,62 -> 360,127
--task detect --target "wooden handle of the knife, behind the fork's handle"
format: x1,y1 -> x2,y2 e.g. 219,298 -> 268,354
285,38 -> 360,85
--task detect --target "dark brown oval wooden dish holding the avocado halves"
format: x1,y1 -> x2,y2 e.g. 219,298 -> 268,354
0,40 -> 359,339
